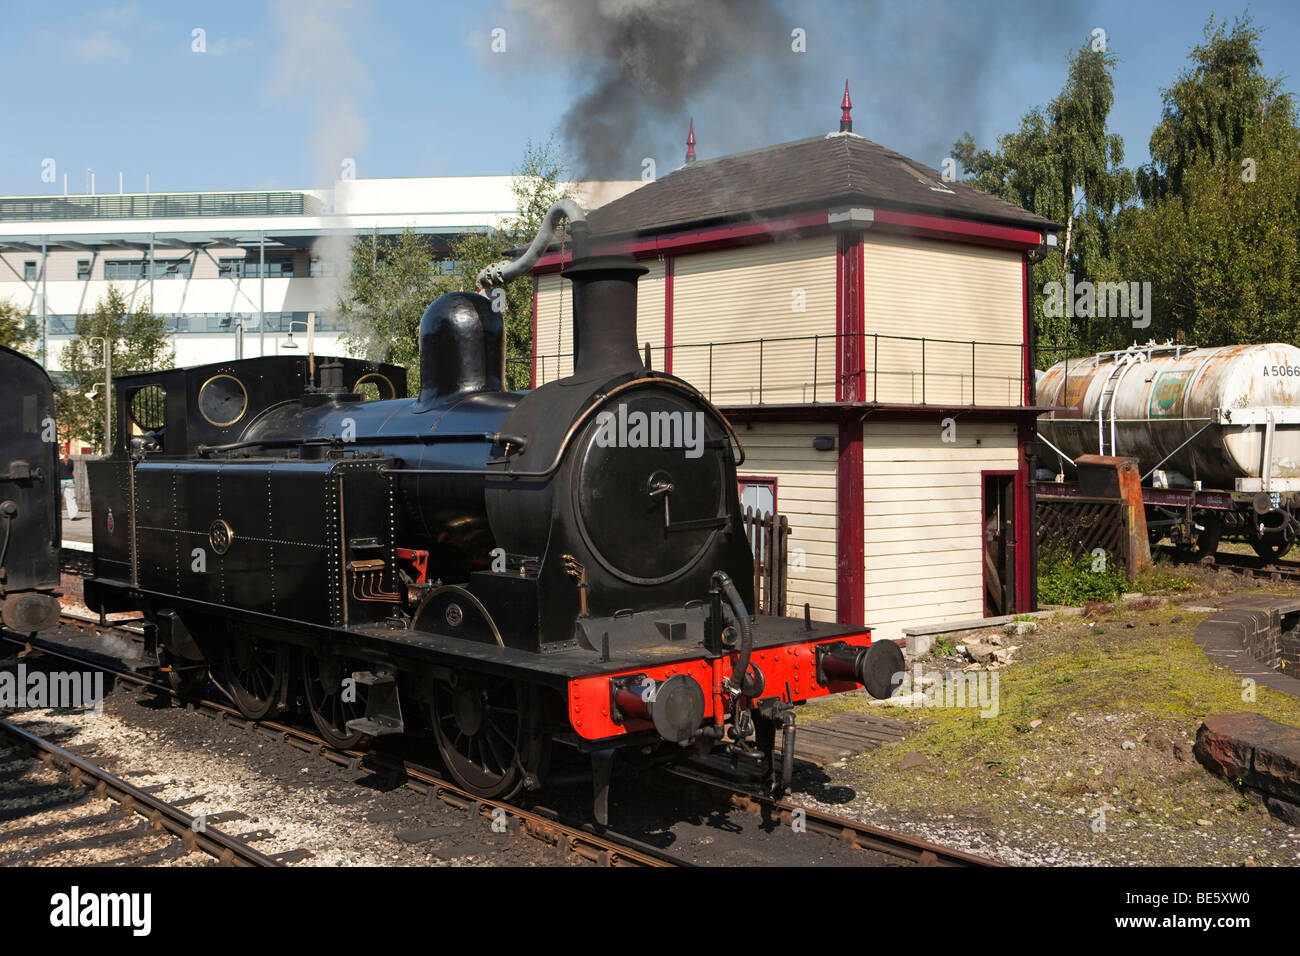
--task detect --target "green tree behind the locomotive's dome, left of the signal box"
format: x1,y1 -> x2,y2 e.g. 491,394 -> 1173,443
339,138 -> 569,394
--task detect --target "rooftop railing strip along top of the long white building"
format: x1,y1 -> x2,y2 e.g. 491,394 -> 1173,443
0,190 -> 320,221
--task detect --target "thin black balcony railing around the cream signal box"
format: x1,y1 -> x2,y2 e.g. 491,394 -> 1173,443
511,332 -> 1027,406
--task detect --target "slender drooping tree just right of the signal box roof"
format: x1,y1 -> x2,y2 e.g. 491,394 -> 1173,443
953,42 -> 1135,367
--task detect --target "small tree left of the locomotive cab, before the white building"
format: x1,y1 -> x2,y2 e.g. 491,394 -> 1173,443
55,285 -> 176,449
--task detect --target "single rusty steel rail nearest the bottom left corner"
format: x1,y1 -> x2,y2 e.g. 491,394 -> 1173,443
0,719 -> 283,866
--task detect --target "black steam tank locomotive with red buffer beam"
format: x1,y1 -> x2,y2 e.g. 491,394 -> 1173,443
85,204 -> 902,819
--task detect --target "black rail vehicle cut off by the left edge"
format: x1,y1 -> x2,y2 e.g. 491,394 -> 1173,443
0,347 -> 62,635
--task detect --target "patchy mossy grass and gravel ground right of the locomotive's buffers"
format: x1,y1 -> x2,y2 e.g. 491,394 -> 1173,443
800,607 -> 1300,864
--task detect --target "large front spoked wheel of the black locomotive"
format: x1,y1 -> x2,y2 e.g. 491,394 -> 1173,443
432,675 -> 550,800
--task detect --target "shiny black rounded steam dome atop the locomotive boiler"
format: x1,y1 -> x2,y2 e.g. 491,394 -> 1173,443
420,293 -> 504,407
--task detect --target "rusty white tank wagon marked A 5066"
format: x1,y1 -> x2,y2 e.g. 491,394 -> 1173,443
1037,343 -> 1300,558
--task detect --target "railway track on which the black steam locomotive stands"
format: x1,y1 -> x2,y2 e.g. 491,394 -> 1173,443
4,613 -> 1001,866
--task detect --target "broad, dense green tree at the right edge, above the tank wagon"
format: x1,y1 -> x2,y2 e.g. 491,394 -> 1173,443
1119,17 -> 1300,345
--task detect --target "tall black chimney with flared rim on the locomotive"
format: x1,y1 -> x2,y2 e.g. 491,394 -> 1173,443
562,256 -> 649,378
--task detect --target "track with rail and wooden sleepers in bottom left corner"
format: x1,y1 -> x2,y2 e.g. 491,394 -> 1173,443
0,719 -> 283,866
